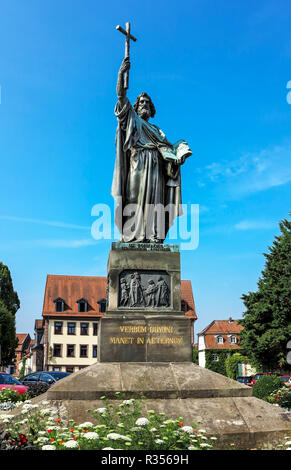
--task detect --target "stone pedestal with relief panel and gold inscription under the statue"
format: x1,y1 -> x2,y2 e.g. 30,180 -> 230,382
98,243 -> 192,362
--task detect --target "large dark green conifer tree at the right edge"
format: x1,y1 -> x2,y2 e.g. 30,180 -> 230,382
240,219 -> 291,371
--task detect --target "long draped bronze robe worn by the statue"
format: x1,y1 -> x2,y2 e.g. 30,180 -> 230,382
111,98 -> 182,242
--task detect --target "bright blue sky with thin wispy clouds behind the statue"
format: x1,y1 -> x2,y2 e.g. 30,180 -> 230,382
0,0 -> 291,335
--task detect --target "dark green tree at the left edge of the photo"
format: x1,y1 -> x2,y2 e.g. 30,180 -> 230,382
0,263 -> 20,366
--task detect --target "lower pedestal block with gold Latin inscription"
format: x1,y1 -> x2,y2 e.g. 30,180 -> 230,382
98,314 -> 192,362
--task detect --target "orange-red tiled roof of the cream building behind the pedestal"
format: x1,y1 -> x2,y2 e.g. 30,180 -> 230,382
42,274 -> 197,321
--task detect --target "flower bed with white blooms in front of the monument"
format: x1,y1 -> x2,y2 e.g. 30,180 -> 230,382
1,397 -> 216,450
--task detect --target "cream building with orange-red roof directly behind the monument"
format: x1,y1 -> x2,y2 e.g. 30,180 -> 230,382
39,275 -> 197,373
